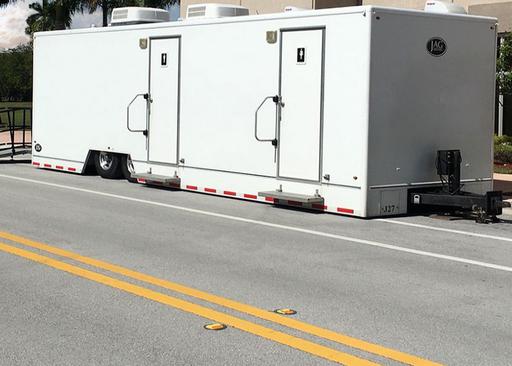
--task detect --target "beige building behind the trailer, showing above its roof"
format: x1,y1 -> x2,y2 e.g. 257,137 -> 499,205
180,0 -> 512,135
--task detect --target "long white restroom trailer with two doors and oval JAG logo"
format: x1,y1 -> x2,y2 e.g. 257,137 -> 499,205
32,6 -> 496,217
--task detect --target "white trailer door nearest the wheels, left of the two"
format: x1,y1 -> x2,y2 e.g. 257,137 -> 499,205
148,37 -> 180,164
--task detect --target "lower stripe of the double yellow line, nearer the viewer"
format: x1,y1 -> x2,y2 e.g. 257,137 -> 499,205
0,243 -> 378,366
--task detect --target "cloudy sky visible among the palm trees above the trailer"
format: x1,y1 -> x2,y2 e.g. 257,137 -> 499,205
0,0 -> 179,50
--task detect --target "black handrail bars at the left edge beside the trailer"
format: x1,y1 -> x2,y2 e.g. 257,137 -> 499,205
0,107 -> 32,159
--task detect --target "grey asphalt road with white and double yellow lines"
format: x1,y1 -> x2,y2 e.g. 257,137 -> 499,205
0,164 -> 512,366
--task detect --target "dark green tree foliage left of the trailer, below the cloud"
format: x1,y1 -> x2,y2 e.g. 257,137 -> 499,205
0,45 -> 32,101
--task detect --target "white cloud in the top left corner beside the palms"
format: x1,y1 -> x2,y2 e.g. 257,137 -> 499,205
0,1 -> 33,49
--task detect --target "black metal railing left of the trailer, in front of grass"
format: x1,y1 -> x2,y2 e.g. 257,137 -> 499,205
0,107 -> 32,159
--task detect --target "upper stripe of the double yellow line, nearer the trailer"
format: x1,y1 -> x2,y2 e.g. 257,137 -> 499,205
0,231 -> 441,366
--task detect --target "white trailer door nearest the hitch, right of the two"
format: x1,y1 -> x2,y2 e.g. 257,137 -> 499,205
278,28 -> 324,181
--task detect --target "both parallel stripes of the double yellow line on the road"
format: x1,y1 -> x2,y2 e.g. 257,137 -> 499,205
0,232 -> 440,366
